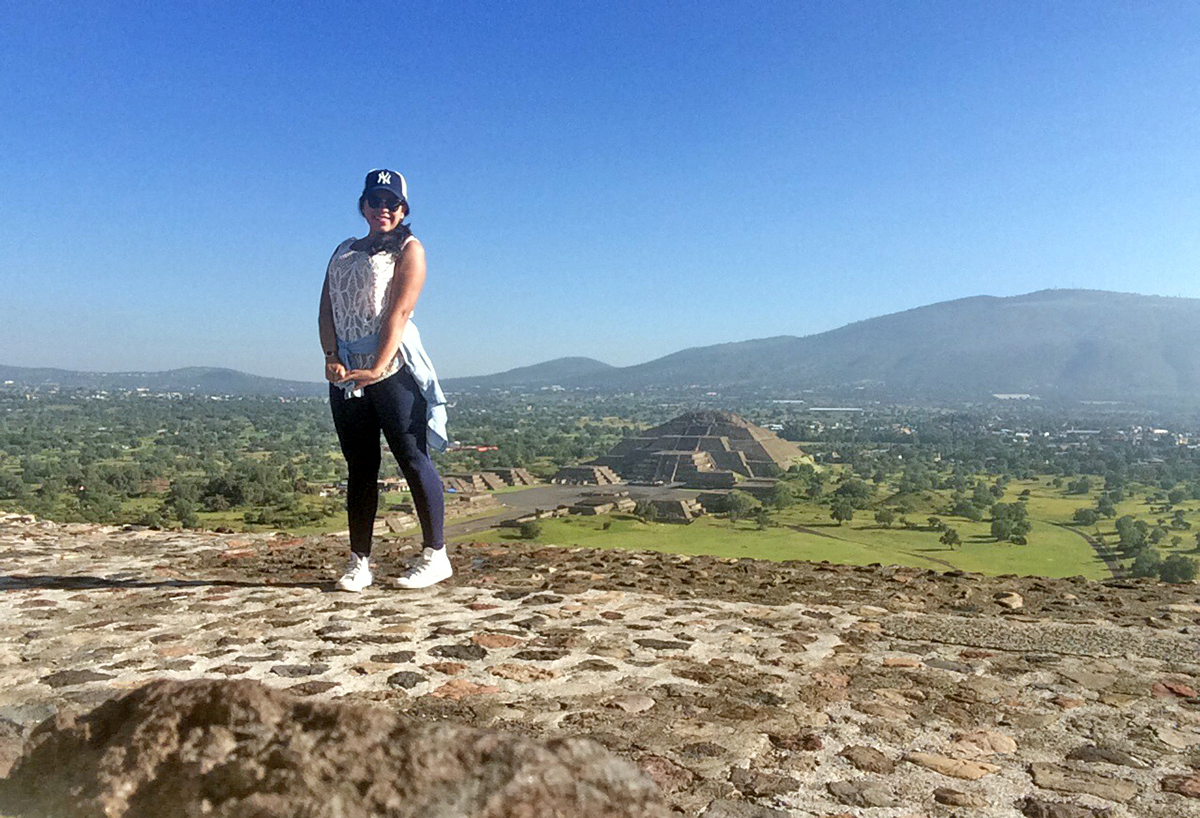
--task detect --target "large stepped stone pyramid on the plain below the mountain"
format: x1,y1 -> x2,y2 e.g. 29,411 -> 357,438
594,411 -> 806,488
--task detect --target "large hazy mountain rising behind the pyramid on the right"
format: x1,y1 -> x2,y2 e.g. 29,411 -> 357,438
465,290 -> 1200,399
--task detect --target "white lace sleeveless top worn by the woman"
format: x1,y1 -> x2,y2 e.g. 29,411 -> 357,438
326,236 -> 413,378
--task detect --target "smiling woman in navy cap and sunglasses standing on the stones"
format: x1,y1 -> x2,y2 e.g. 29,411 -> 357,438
319,169 -> 452,591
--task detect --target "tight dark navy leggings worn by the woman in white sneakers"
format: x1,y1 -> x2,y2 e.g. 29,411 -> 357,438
329,369 -> 445,557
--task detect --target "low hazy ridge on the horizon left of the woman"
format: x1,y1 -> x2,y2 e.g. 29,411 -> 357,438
0,366 -> 328,396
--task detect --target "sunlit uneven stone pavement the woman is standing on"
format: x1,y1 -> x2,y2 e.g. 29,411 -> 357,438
0,516 -> 1200,818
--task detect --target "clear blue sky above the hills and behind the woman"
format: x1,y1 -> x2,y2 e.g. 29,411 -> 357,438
0,0 -> 1200,380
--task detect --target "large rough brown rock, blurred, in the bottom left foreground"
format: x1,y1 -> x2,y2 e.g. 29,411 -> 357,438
0,680 -> 666,818
